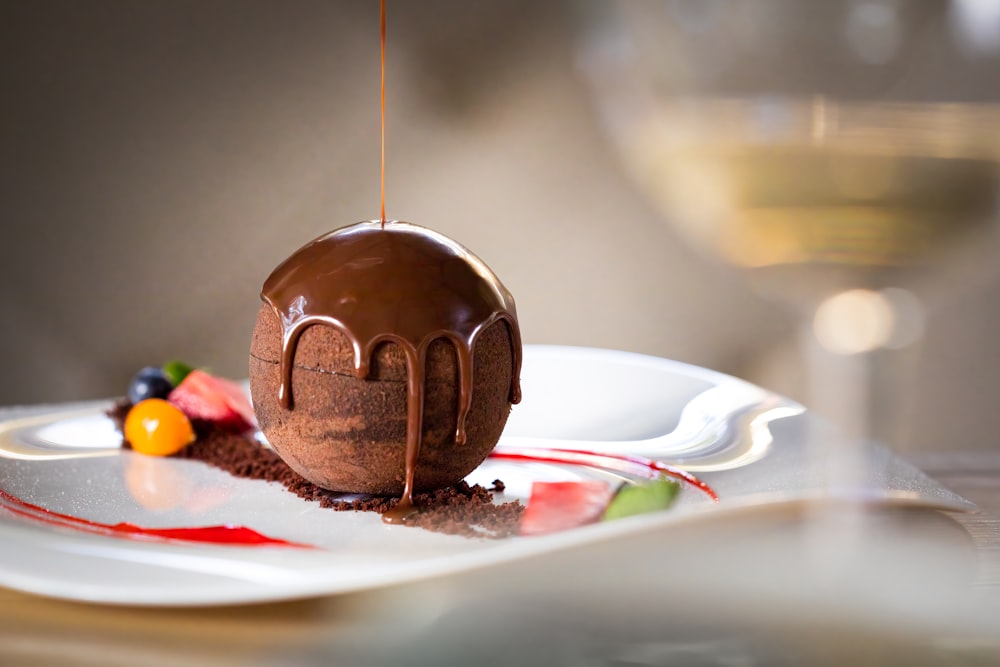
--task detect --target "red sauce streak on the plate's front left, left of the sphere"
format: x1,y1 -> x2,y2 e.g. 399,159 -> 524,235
0,489 -> 313,549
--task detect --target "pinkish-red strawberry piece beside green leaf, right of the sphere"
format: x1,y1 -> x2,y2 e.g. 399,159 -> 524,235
521,480 -> 616,535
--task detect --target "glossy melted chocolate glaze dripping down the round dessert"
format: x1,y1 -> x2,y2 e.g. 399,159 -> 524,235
261,221 -> 521,523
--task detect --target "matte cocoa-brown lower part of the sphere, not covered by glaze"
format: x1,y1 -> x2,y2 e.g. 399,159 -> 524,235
250,304 -> 513,495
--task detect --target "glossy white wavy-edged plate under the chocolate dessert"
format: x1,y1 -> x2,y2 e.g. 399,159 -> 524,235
0,346 -> 970,605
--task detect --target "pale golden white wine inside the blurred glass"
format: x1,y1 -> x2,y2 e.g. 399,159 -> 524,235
618,96 -> 1000,308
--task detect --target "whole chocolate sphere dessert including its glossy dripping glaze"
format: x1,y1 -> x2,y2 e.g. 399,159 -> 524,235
250,222 -> 521,500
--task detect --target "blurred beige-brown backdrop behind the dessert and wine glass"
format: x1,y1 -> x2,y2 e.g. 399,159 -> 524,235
0,0 -> 1000,460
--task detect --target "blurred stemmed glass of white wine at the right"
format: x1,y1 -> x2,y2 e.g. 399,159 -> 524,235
575,0 -> 1000,560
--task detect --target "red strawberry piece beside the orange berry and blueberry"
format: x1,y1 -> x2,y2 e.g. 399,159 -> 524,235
167,369 -> 257,433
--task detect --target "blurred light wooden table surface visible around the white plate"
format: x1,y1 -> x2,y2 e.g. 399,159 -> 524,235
0,452 -> 1000,666
